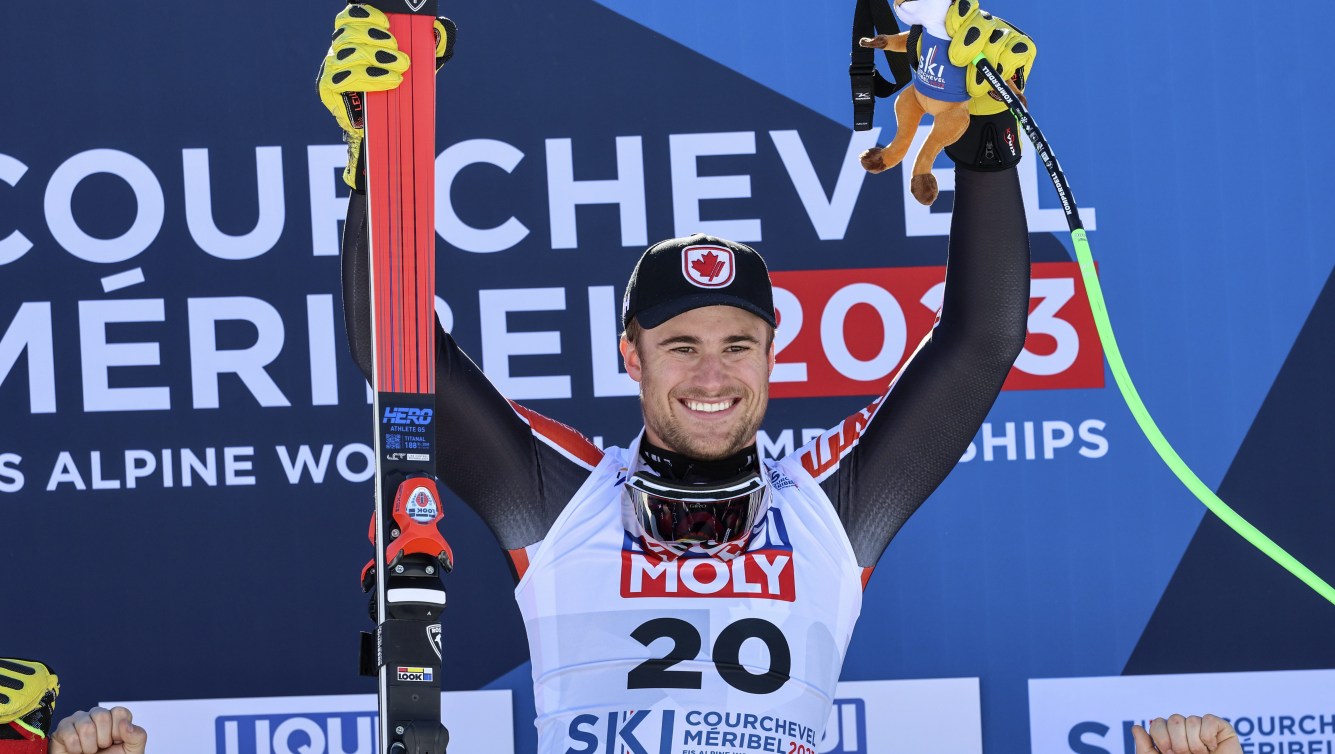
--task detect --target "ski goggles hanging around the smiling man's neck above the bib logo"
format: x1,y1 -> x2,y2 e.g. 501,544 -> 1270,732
625,471 -> 769,552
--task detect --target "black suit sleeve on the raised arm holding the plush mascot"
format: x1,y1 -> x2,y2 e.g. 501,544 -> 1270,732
817,168 -> 1029,567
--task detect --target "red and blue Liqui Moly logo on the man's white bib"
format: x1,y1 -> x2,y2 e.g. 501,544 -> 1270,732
621,507 -> 797,602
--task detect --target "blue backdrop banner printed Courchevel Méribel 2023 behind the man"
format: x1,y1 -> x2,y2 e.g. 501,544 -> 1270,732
0,0 -> 1335,754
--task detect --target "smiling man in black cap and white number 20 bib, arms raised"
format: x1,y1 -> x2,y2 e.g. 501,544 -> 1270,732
320,5 -> 1029,754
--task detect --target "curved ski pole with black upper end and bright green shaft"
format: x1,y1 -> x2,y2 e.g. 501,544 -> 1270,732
973,55 -> 1335,605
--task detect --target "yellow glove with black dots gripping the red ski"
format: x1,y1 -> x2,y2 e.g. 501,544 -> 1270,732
318,5 -> 458,191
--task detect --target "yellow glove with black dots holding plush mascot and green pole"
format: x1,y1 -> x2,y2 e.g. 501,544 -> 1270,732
945,0 -> 1039,115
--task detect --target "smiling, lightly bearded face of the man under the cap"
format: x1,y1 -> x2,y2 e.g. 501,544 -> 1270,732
621,306 -> 774,460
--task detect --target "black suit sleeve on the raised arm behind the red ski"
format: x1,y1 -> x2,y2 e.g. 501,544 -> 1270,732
342,192 -> 601,551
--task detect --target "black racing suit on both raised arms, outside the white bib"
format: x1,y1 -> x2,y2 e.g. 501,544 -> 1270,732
343,168 -> 1029,583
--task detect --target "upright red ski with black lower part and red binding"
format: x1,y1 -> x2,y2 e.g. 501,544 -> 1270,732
362,0 -> 453,754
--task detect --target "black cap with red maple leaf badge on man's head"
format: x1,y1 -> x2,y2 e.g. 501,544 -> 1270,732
621,234 -> 774,330
